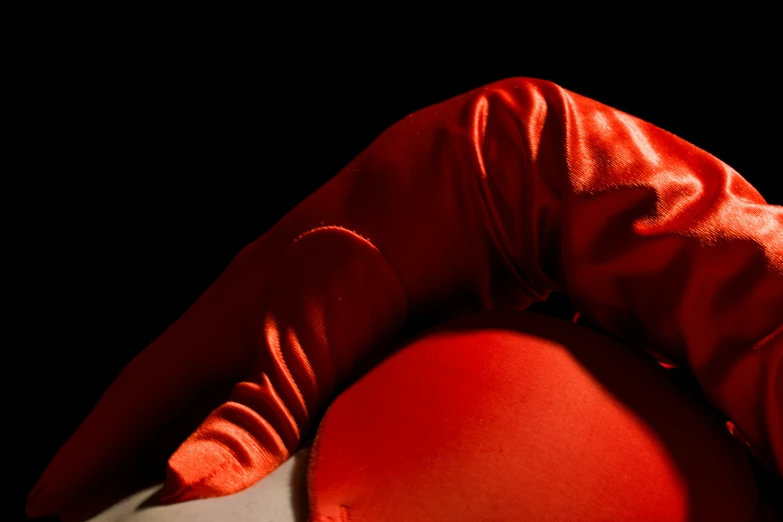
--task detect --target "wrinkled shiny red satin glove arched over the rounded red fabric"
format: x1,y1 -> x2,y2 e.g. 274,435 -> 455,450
28,79 -> 783,515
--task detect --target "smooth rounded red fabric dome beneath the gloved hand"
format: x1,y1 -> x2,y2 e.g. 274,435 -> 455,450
308,312 -> 757,522
